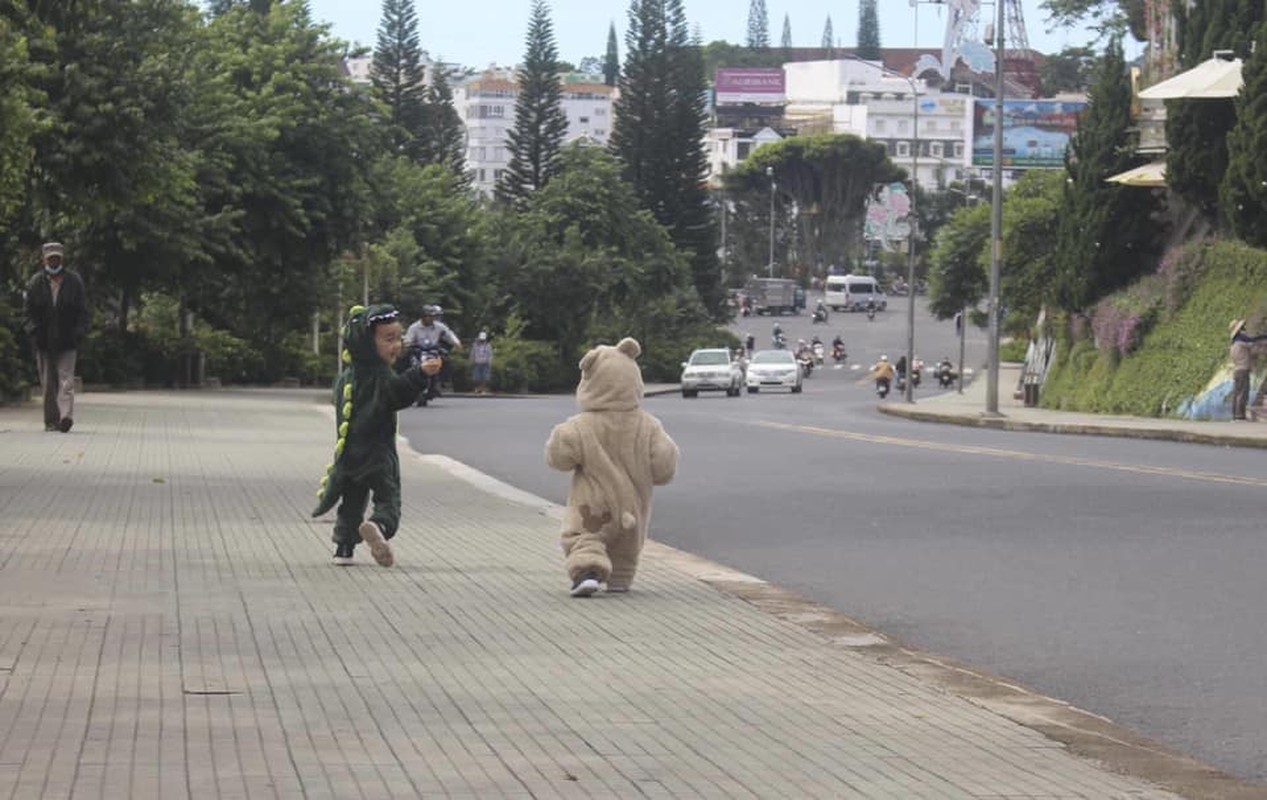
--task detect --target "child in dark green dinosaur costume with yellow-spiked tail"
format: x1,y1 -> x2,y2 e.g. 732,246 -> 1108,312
313,306 -> 440,567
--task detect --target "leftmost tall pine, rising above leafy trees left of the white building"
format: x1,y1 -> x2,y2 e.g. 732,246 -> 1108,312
370,0 -> 427,161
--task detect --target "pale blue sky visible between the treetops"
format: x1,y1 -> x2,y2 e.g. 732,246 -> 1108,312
309,0 -> 1109,67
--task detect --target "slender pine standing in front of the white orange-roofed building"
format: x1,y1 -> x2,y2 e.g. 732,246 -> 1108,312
497,0 -> 568,203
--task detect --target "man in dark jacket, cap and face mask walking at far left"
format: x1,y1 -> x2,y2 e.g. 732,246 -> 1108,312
23,242 -> 91,434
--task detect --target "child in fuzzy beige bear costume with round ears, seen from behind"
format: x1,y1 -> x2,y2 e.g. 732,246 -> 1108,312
546,339 -> 678,597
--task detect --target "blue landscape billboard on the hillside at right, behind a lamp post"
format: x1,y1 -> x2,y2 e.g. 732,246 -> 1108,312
972,99 -> 1087,169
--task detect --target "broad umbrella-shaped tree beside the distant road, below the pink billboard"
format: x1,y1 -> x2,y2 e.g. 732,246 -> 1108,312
726,133 -> 905,278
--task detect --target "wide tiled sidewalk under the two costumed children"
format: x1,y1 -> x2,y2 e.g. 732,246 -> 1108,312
0,392 -> 1249,799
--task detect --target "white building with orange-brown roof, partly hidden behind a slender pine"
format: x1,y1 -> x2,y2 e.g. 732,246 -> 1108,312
454,67 -> 614,195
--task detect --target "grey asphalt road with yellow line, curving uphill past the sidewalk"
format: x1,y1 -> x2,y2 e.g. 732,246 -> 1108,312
400,307 -> 1267,784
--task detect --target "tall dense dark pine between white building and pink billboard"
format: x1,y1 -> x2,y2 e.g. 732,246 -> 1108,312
611,0 -> 723,314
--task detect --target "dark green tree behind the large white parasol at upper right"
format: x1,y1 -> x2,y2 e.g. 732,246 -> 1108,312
1166,0 -> 1264,218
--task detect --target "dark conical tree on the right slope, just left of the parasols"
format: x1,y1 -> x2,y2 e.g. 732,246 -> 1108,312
1054,39 -> 1157,311
